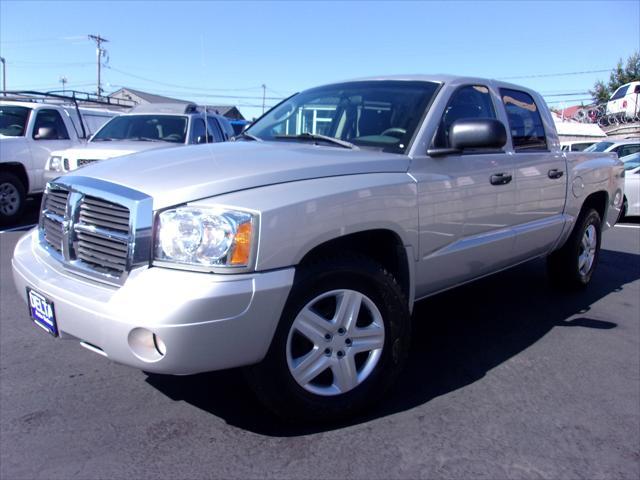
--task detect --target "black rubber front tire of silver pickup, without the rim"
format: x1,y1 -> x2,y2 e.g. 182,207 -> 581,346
245,255 -> 411,422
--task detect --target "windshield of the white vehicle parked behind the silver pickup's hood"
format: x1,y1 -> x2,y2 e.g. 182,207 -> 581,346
91,115 -> 187,143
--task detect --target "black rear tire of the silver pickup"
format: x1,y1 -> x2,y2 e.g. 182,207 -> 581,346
547,208 -> 602,290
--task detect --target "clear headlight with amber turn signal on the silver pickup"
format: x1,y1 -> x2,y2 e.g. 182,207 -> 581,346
155,207 -> 257,268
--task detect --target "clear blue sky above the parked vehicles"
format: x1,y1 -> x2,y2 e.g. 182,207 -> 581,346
0,0 -> 640,117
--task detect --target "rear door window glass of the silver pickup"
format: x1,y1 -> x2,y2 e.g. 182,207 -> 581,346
500,88 -> 547,152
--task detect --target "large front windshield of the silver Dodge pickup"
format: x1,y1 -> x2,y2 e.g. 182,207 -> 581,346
247,81 -> 438,153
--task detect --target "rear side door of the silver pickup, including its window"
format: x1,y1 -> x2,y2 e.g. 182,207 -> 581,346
500,88 -> 567,261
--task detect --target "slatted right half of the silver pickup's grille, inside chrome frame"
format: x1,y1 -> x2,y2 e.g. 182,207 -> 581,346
74,196 -> 130,275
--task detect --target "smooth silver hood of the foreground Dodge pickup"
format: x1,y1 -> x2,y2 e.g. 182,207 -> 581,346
64,142 -> 409,209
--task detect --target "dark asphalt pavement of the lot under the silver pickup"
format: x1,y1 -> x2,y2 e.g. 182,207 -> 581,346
0,223 -> 640,480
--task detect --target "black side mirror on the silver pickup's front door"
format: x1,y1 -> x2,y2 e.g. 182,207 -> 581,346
427,118 -> 507,157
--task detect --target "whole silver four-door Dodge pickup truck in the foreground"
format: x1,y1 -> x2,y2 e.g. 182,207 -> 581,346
13,76 -> 624,420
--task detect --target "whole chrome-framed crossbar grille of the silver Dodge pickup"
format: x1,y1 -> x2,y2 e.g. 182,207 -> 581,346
40,176 -> 153,285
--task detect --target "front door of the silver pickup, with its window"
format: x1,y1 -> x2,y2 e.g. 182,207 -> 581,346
411,85 -> 515,298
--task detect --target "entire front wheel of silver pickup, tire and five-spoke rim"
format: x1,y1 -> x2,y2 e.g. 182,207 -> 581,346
247,256 -> 410,421
